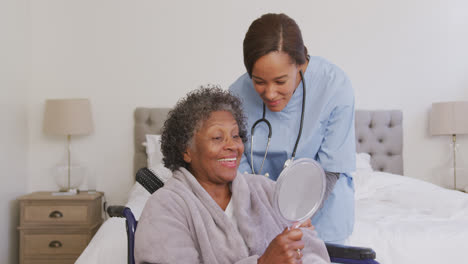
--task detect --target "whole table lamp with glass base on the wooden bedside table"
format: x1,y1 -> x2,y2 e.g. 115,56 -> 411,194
44,99 -> 94,192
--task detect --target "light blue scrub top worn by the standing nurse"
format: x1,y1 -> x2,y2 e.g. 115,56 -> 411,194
229,57 -> 356,242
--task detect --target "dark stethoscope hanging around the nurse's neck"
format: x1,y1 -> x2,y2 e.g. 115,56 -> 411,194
250,70 -> 306,174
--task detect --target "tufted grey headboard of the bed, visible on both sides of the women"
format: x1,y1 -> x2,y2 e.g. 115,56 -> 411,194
133,107 -> 403,175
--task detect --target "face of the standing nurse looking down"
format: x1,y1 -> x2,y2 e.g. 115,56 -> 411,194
252,51 -> 301,112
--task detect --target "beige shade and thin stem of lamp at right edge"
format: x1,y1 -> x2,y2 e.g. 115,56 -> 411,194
430,101 -> 468,190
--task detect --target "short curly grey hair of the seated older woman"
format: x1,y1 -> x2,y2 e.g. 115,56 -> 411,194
161,85 -> 247,171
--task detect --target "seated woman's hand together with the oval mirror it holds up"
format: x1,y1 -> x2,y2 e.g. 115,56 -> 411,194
266,158 -> 326,263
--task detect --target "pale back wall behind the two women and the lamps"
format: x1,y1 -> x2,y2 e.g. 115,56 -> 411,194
28,0 -> 468,208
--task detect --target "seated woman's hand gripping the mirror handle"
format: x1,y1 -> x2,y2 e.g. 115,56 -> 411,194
258,227 -> 306,264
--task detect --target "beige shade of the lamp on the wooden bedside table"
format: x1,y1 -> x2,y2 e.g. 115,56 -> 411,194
44,99 -> 94,135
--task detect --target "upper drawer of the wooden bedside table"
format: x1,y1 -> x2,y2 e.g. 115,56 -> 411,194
23,204 -> 88,224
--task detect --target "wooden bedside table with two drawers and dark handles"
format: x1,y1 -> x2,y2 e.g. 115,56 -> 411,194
18,192 -> 103,264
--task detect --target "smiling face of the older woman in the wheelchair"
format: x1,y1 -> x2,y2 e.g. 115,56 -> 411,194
184,111 -> 244,186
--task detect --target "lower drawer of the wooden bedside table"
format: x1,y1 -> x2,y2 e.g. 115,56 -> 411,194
23,234 -> 88,257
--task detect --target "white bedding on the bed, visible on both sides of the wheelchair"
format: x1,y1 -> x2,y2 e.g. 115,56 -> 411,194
76,165 -> 468,264
